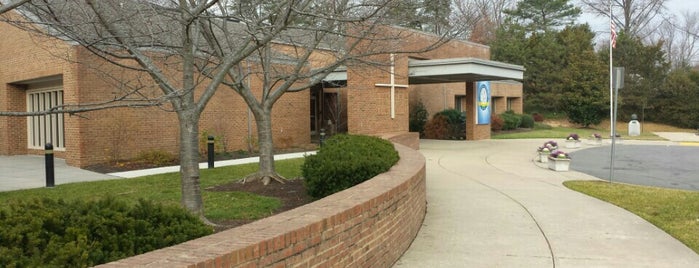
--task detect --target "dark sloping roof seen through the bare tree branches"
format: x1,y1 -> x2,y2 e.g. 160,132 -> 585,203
14,0 -> 343,59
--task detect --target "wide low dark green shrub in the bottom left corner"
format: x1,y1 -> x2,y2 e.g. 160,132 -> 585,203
0,197 -> 213,267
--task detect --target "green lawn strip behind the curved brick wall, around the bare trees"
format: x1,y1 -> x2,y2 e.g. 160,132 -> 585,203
0,158 -> 304,220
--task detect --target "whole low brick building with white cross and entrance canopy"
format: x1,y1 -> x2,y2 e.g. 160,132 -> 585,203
0,12 -> 523,167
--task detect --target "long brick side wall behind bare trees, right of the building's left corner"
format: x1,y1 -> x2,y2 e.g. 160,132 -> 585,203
69,52 -> 310,166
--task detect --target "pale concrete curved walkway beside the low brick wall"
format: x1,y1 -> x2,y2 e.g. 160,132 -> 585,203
395,139 -> 699,268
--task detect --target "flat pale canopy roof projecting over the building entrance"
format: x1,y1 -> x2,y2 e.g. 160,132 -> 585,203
408,58 -> 524,85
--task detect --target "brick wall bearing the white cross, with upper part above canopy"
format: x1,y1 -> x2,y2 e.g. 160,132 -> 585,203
347,28 -> 490,134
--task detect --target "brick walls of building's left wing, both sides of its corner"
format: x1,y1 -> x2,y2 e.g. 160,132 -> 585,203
0,17 -> 310,167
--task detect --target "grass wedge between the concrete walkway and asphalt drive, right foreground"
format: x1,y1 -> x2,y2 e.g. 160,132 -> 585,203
563,181 -> 699,253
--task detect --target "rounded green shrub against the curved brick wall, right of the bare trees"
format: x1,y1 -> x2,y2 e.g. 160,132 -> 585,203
302,134 -> 399,199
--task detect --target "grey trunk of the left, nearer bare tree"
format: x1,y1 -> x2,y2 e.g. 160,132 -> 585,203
177,109 -> 204,219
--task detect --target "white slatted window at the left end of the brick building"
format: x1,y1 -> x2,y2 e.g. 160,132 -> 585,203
27,88 -> 65,150
